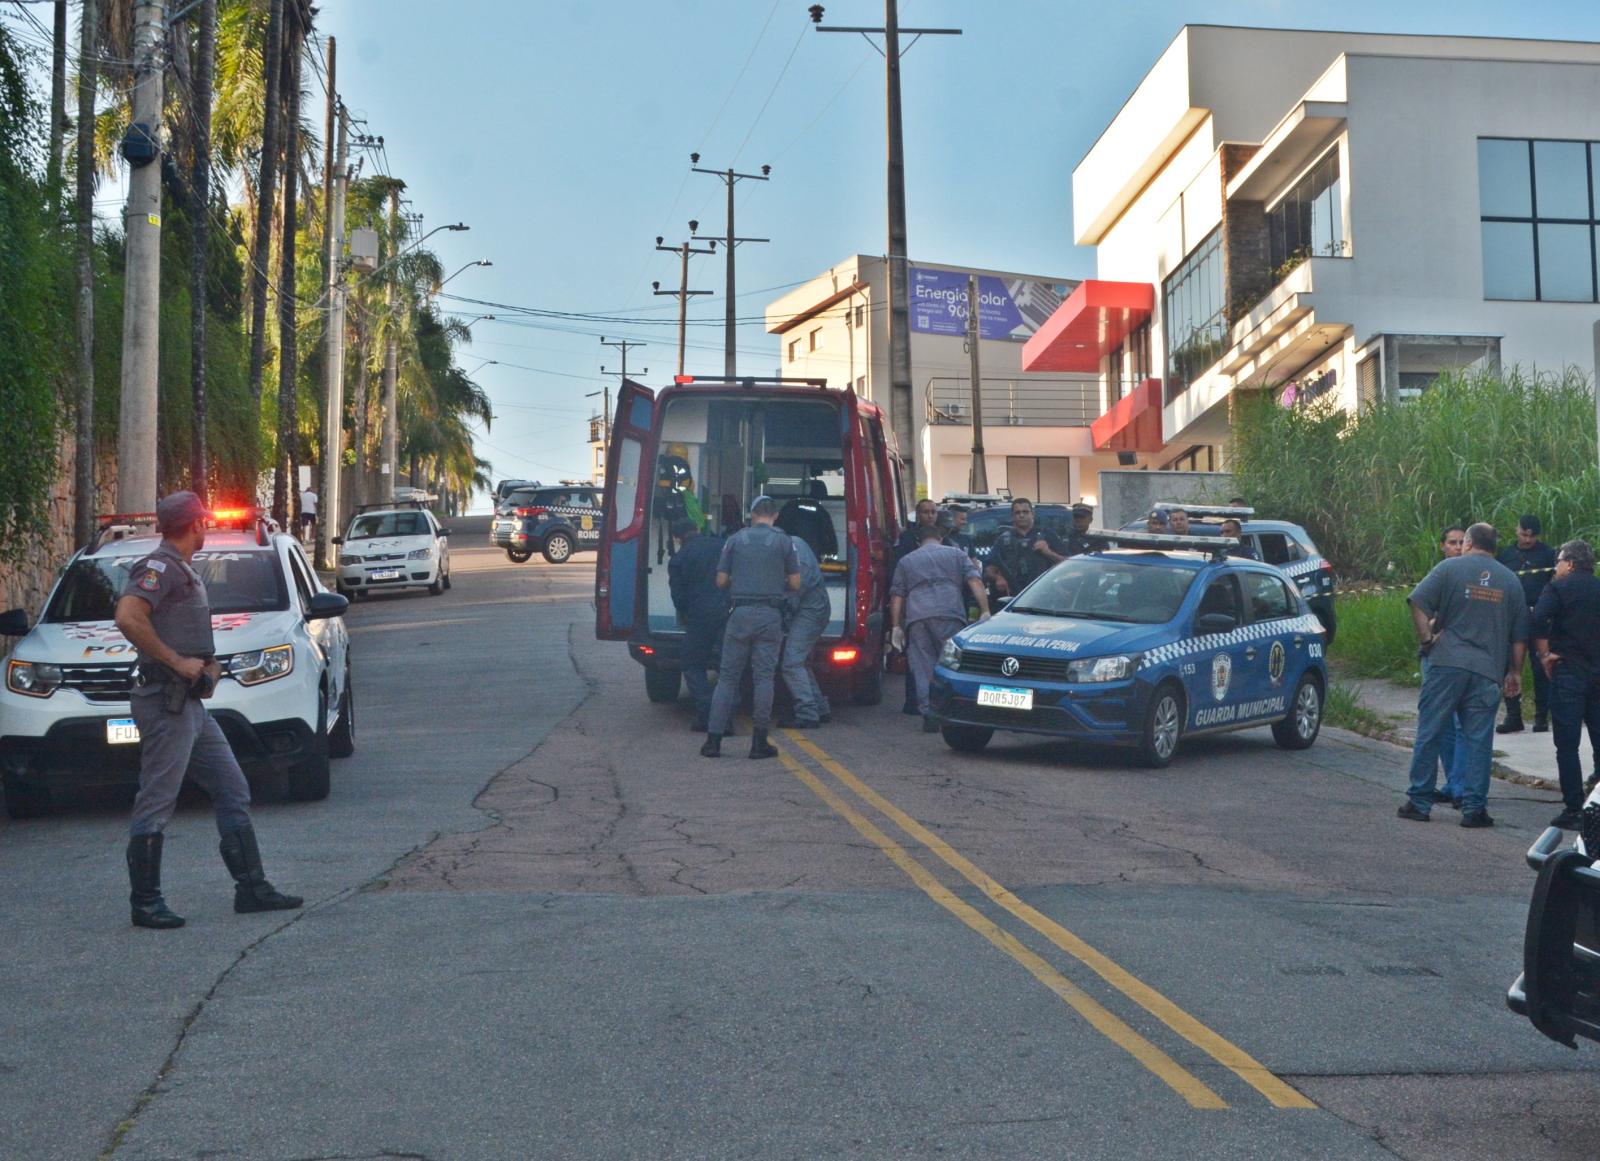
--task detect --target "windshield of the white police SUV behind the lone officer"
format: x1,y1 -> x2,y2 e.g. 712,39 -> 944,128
45,549 -> 290,624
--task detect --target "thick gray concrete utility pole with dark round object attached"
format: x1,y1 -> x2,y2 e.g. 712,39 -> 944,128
116,0 -> 166,512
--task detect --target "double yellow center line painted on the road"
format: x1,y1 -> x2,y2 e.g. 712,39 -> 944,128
779,729 -> 1315,1108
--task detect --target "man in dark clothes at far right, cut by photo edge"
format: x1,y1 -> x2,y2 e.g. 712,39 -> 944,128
1533,541 -> 1600,830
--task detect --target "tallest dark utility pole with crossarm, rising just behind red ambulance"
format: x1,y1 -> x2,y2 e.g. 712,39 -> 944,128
810,0 -> 962,488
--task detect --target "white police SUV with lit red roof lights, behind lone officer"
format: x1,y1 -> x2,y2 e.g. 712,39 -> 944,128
0,510 -> 355,819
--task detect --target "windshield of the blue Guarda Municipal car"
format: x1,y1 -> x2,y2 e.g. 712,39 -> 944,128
1006,557 -> 1195,625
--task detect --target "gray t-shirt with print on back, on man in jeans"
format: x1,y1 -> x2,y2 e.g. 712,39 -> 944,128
1411,552 -> 1528,681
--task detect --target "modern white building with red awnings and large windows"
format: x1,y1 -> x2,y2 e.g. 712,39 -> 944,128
1022,26 -> 1600,469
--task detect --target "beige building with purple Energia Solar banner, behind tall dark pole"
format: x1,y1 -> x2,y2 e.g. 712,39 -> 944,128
766,254 -> 1117,502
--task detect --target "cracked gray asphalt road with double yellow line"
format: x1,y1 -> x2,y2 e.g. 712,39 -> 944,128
0,537 -> 1600,1161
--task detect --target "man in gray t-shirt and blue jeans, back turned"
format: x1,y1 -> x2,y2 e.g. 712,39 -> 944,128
1398,525 -> 1528,827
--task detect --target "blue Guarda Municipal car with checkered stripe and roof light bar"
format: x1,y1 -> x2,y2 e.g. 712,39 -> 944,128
930,533 -> 1328,766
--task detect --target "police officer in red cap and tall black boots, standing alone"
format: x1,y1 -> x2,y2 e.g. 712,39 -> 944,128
117,493 -> 302,929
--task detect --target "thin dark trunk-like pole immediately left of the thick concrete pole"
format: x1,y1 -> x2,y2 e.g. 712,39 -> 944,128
72,0 -> 99,549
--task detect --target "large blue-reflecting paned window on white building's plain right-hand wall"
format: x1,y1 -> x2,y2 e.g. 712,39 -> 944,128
1478,138 -> 1600,302
